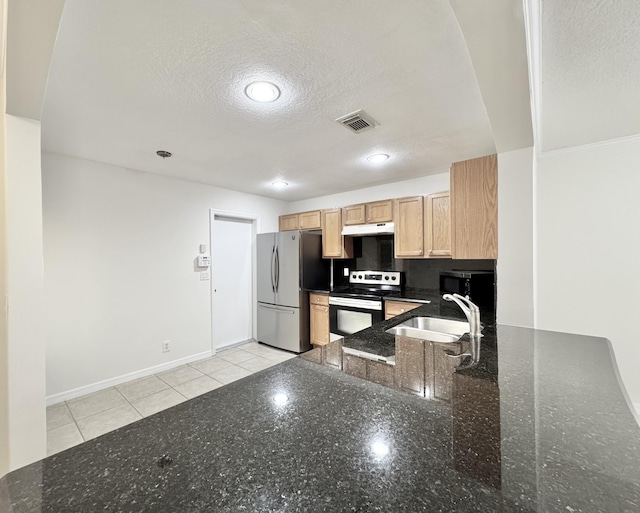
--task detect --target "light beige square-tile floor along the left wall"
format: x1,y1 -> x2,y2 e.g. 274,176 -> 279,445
47,342 -> 296,456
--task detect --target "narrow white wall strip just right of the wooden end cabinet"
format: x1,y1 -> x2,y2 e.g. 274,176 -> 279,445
496,148 -> 534,327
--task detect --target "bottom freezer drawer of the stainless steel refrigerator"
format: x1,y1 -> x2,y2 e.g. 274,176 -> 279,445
258,303 -> 303,353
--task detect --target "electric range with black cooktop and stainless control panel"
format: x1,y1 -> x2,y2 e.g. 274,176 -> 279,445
329,271 -> 403,339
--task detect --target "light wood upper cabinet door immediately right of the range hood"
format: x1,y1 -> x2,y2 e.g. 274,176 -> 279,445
394,196 -> 424,258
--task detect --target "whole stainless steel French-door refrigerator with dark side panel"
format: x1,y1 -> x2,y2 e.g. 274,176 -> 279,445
257,231 -> 329,353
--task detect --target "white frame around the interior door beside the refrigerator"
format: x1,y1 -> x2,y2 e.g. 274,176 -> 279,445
209,208 -> 260,355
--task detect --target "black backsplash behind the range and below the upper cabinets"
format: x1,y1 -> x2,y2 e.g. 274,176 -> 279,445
333,235 -> 496,289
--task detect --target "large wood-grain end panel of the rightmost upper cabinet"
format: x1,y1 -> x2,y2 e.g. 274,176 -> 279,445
451,151 -> 498,259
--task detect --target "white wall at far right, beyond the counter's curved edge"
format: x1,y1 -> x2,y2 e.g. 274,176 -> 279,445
536,138 -> 640,404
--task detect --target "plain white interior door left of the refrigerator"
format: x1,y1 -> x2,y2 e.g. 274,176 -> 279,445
211,215 -> 253,349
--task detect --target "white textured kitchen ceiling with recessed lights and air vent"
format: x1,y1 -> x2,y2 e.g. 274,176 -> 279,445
42,0 -> 495,201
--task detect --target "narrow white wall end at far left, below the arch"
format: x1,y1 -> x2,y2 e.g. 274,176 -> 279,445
5,115 -> 46,469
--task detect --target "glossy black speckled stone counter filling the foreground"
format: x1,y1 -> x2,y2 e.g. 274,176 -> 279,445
0,328 -> 640,513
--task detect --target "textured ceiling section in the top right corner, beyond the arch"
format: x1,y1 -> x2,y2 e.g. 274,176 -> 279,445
540,0 -> 640,151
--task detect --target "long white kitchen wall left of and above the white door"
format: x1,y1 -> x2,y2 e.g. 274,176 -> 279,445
43,153 -> 286,399
